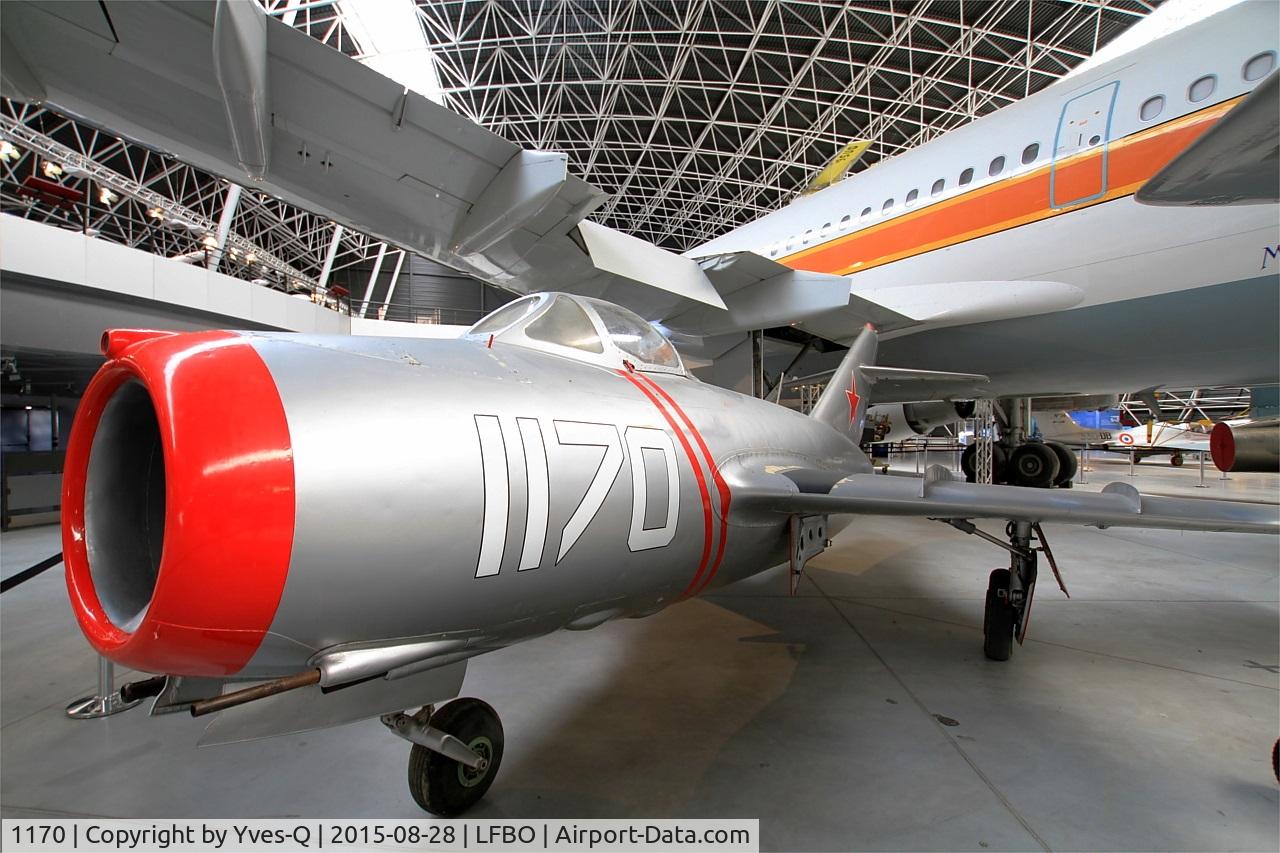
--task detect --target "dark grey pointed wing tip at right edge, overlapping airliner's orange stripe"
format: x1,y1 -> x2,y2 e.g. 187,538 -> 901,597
1134,72 -> 1280,206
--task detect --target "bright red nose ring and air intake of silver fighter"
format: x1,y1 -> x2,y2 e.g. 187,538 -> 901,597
63,330 -> 294,676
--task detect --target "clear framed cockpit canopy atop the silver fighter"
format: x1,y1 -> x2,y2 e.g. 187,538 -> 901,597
463,293 -> 685,375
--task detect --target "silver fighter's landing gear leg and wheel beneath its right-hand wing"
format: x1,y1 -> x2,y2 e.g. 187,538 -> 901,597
946,519 -> 1071,661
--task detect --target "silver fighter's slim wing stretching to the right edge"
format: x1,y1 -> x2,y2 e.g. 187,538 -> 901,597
733,466 -> 1280,534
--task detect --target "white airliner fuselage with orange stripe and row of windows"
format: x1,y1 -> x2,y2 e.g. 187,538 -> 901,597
689,3 -> 1280,394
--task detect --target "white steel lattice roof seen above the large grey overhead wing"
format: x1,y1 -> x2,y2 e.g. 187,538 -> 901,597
260,0 -> 1158,251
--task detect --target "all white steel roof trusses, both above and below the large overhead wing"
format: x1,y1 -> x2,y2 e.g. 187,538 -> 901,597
0,0 -> 1157,296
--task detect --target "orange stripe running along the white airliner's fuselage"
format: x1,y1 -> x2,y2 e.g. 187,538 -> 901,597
780,95 -> 1243,275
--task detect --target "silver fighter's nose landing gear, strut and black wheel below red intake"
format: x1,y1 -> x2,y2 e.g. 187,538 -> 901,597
381,698 -> 503,817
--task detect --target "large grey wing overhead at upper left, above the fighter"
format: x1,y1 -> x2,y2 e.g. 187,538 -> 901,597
0,3 -> 742,319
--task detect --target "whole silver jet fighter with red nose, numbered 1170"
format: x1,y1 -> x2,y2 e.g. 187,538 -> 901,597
63,293 -> 1277,815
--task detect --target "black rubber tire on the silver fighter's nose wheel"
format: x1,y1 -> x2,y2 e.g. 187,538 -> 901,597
408,698 -> 503,817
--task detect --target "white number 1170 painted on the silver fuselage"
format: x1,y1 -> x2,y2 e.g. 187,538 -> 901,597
475,415 -> 680,578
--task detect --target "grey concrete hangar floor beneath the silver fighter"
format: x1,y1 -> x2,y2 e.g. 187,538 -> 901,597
0,460 -> 1280,850
